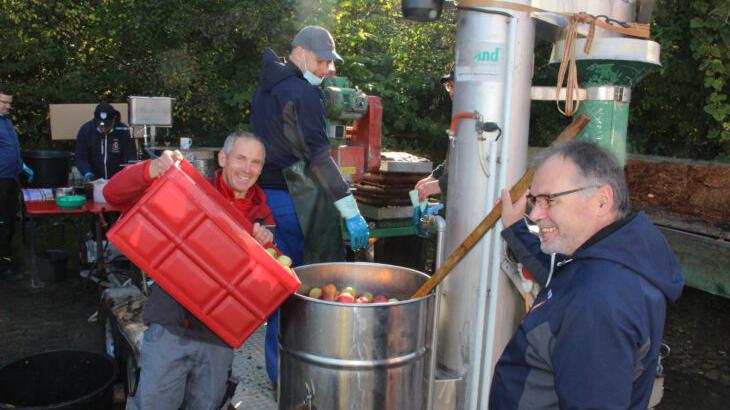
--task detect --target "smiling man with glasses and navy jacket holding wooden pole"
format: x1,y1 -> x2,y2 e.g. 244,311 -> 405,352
489,141 -> 684,410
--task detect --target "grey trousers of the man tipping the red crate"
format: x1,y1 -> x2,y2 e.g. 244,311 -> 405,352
126,323 -> 233,410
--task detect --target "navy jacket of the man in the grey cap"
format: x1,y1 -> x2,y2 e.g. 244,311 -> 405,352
251,49 -> 349,200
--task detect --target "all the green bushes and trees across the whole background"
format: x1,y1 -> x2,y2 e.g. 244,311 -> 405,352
0,0 -> 730,161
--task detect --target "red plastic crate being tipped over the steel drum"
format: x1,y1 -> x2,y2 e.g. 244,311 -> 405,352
107,161 -> 301,348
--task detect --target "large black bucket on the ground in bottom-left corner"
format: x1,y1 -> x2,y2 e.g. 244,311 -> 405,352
0,350 -> 117,410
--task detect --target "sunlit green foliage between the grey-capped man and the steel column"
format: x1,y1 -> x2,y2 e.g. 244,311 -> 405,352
326,0 -> 455,160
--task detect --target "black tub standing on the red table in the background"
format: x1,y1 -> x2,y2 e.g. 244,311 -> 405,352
23,150 -> 73,188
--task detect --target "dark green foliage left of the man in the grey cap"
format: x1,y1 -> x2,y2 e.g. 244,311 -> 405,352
0,0 -> 296,148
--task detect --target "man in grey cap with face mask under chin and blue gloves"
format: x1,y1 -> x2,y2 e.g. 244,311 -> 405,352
251,26 -> 369,383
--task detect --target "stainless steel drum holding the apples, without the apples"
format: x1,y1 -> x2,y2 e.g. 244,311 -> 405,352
279,263 -> 434,410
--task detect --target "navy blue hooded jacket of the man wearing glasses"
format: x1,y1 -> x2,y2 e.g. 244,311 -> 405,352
489,213 -> 684,410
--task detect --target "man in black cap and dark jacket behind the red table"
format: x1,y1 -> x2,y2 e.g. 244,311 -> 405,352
76,103 -> 137,182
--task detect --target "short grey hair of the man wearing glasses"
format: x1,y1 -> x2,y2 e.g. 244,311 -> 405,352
533,140 -> 631,219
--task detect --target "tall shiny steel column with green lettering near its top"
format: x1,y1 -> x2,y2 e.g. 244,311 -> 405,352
435,0 -> 534,409
